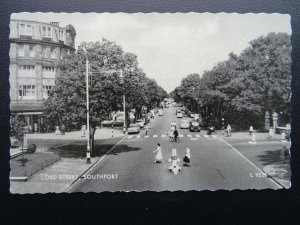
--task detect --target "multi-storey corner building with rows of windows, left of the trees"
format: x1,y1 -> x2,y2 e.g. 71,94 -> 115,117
9,19 -> 76,132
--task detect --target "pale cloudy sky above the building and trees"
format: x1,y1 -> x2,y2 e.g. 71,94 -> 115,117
11,13 -> 292,92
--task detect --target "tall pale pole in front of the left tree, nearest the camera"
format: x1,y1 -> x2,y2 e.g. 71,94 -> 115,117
86,58 -> 91,163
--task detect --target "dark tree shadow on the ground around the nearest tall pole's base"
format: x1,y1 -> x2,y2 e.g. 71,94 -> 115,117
49,144 -> 141,158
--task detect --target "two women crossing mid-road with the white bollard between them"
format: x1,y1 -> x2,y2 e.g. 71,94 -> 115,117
153,143 -> 191,174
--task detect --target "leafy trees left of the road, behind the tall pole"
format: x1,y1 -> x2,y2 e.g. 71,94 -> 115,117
45,39 -> 168,150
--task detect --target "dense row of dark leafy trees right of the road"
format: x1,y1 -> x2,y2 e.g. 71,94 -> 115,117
170,33 -> 292,129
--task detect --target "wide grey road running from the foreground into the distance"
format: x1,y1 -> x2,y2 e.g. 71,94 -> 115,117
70,107 -> 281,192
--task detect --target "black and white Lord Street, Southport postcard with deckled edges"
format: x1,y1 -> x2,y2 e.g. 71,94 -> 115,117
9,12 -> 292,194
